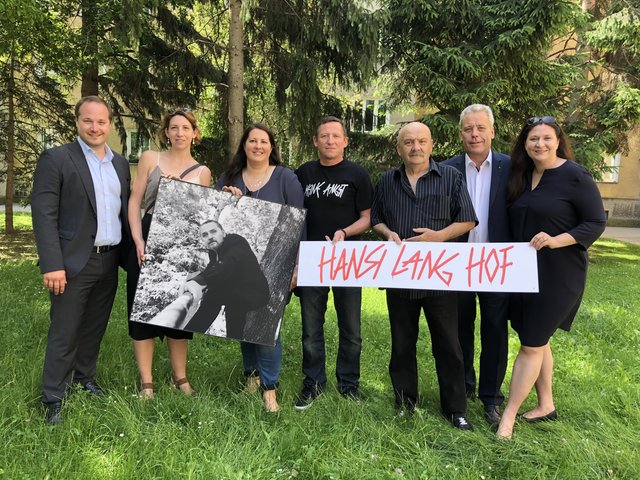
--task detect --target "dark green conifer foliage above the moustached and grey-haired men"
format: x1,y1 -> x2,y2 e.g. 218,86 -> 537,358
382,0 -> 579,157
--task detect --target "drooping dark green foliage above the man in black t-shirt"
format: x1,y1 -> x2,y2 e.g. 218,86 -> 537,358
245,0 -> 386,144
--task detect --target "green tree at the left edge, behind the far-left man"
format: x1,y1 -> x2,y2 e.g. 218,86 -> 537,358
0,0 -> 74,233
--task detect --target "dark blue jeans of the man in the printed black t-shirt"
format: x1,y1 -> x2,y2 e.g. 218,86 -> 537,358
300,287 -> 362,392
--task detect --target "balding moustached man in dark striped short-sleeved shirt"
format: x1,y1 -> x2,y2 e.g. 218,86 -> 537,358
371,122 -> 478,430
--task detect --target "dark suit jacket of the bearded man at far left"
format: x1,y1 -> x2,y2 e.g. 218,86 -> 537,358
31,141 -> 131,278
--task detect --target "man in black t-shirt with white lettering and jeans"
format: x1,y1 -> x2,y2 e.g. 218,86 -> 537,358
296,117 -> 373,410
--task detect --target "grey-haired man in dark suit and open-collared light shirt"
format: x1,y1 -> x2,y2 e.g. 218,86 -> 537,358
444,104 -> 511,424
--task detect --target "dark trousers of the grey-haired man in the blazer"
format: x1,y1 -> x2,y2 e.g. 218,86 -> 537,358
458,292 -> 509,405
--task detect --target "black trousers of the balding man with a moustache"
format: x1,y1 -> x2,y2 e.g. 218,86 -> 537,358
387,290 -> 467,415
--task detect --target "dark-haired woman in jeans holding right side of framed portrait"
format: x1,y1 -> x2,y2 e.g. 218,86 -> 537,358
216,123 -> 304,412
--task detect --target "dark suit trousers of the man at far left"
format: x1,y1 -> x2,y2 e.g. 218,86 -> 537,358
42,248 -> 119,403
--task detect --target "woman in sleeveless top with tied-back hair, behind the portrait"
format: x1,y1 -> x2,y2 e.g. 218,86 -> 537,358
127,109 -> 211,399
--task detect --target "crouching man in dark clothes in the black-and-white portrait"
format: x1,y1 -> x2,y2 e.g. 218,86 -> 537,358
180,220 -> 269,340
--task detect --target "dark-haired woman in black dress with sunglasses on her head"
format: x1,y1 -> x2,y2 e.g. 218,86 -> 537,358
497,117 -> 606,439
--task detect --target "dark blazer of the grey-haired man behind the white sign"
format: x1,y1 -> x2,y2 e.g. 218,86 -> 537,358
442,150 -> 511,242
